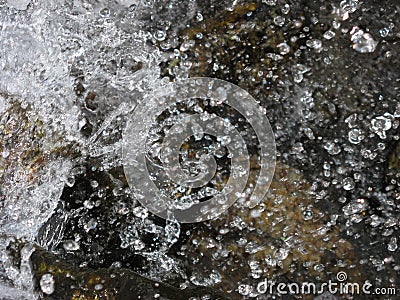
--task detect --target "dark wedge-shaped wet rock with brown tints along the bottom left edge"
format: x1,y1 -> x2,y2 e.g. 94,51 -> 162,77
31,248 -> 228,300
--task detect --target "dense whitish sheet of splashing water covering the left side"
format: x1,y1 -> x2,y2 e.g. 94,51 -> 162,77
0,0 -> 167,299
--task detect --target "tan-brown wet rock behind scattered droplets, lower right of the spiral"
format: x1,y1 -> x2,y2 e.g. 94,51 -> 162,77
187,164 -> 367,298
